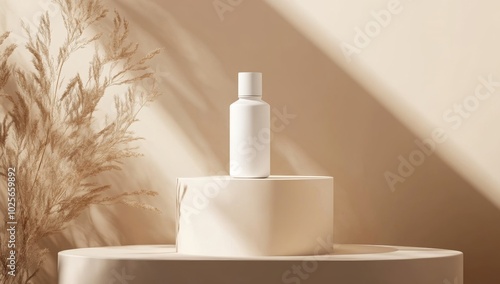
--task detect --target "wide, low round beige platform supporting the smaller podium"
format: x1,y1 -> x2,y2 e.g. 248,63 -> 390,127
58,245 -> 463,284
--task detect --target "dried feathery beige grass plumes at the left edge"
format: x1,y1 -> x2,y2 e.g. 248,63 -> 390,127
0,0 -> 159,283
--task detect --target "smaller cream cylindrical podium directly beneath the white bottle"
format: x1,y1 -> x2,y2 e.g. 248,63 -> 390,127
177,176 -> 333,257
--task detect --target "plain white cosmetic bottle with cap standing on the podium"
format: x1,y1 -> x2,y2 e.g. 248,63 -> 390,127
229,72 -> 271,178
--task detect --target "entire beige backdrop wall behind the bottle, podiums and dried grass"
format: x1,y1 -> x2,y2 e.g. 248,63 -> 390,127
0,0 -> 500,284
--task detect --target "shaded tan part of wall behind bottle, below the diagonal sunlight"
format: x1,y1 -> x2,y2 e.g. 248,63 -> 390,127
28,0 -> 500,283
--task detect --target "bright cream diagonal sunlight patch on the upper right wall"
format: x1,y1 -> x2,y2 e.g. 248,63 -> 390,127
266,0 -> 500,208
